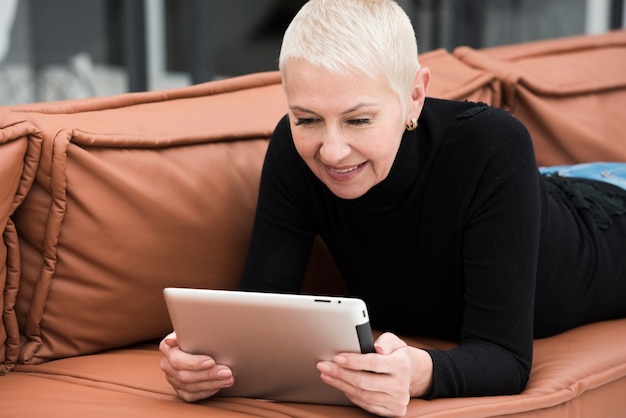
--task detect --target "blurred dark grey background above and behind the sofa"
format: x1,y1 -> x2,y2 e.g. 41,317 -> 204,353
0,0 -> 626,105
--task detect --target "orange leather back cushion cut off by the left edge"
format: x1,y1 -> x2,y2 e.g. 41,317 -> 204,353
0,114 -> 41,375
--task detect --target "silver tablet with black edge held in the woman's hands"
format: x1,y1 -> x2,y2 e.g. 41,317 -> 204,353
163,288 -> 374,405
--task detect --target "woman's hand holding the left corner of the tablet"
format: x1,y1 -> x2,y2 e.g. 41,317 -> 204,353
159,332 -> 235,402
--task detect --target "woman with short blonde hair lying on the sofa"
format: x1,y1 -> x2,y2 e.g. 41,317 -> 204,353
161,0 -> 626,416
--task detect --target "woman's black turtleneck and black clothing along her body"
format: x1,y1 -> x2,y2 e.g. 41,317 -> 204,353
241,99 -> 626,397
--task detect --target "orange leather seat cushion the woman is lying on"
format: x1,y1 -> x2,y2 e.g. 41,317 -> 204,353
7,319 -> 626,418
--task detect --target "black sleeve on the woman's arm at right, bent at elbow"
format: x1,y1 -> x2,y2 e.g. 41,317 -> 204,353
428,108 -> 541,398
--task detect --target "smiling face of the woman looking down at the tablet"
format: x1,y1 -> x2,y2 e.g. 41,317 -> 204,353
284,60 -> 410,199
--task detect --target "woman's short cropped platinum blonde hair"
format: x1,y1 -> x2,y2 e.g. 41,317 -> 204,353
278,0 -> 420,109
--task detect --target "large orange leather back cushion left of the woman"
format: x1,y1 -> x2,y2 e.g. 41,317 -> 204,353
12,73 -> 285,364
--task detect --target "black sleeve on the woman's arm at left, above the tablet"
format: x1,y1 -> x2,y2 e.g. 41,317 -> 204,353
240,117 -> 316,293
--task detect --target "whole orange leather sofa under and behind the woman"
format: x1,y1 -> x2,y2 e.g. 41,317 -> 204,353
0,31 -> 626,418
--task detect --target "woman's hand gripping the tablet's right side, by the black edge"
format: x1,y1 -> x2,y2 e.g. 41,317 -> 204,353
317,333 -> 433,417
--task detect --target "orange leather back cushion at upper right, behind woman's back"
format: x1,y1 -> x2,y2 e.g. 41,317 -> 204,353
454,30 -> 626,165
